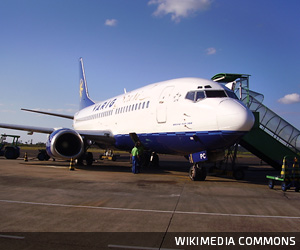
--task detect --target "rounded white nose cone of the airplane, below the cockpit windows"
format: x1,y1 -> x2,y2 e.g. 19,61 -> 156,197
217,99 -> 254,131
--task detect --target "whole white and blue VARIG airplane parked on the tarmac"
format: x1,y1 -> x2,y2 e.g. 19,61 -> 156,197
0,58 -> 254,180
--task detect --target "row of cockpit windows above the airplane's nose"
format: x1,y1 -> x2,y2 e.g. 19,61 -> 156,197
185,90 -> 238,102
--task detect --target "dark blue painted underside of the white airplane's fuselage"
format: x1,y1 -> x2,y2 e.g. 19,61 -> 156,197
115,131 -> 246,155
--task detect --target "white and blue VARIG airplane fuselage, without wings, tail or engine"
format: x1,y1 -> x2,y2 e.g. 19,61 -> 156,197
73,78 -> 254,155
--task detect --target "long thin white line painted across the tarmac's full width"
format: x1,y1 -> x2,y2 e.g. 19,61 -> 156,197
0,200 -> 300,219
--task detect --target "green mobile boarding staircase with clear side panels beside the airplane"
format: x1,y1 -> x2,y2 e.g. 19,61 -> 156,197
212,73 -> 300,170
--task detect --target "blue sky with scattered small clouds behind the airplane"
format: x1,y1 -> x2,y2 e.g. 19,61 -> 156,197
0,0 -> 300,141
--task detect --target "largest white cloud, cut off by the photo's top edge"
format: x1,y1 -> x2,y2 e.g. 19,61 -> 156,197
148,0 -> 213,22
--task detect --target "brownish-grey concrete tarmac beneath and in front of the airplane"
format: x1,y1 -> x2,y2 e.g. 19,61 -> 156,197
0,151 -> 300,250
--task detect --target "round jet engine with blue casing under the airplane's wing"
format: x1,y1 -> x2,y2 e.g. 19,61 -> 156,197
46,128 -> 84,160
